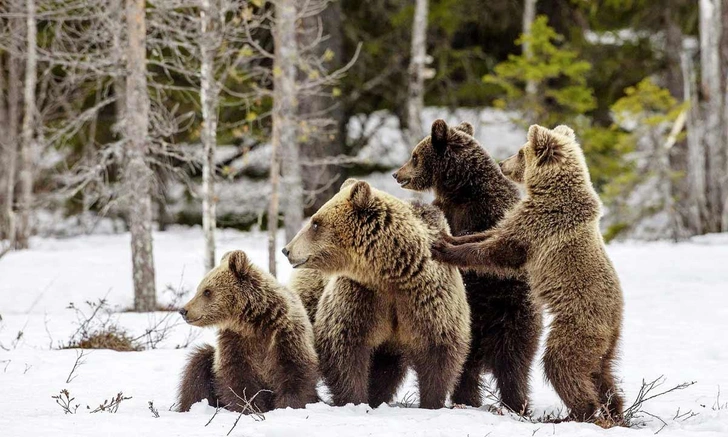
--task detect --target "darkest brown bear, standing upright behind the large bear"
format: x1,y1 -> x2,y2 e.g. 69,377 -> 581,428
393,120 -> 542,413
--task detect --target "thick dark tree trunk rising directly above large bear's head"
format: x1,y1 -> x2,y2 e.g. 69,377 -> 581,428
298,1 -> 346,216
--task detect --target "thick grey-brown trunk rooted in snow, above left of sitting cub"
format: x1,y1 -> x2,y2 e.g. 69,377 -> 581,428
124,0 -> 157,311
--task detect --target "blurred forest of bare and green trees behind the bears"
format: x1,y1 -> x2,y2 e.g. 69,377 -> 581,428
0,0 -> 728,300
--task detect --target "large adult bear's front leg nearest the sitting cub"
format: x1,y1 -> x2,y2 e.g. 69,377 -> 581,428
314,277 -> 381,406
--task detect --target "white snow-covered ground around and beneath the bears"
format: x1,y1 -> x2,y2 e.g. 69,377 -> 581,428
0,228 -> 728,437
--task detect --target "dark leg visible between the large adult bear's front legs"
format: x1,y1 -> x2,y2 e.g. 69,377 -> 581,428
369,344 -> 407,408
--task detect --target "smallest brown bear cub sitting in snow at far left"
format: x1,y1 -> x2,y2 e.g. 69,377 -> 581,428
178,250 -> 318,412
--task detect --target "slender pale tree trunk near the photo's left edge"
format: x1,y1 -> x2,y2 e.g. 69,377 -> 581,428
16,0 -> 38,249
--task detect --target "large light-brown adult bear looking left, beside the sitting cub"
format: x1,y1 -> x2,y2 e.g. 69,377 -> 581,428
283,180 -> 470,408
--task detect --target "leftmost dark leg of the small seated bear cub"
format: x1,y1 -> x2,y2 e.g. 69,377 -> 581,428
177,344 -> 217,412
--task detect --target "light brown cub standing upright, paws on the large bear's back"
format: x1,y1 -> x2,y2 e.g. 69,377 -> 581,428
433,125 -> 623,420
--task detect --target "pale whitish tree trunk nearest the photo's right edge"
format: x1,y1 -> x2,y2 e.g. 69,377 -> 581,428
700,0 -> 725,232
